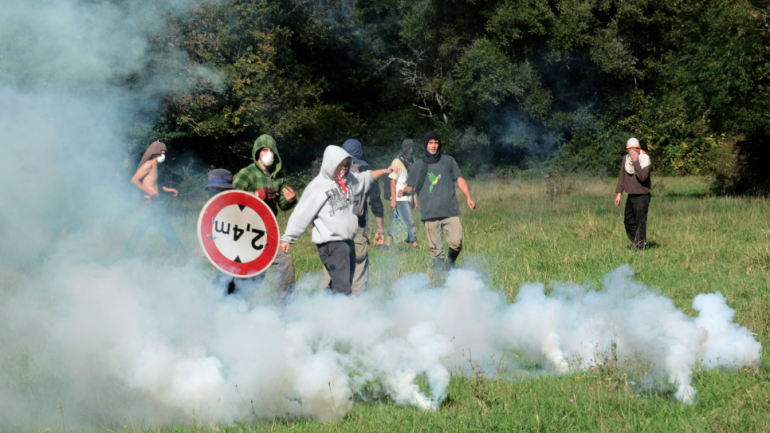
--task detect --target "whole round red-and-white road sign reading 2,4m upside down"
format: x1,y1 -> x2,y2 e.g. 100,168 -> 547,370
198,190 -> 281,278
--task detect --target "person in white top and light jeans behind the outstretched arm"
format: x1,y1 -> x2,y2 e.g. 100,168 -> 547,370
385,138 -> 419,249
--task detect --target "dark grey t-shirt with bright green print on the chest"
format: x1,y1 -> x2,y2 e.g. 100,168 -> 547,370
406,155 -> 463,221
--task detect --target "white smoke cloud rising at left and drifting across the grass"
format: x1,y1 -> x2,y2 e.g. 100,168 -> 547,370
0,0 -> 760,431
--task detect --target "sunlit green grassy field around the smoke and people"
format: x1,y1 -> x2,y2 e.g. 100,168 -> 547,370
1,178 -> 770,432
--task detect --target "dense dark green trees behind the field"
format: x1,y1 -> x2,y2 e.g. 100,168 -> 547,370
147,0 -> 770,187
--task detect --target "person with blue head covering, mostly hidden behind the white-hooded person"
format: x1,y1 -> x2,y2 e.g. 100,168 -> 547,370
321,138 -> 385,296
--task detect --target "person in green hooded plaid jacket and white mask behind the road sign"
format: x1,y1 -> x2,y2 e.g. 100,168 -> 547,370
233,134 -> 297,306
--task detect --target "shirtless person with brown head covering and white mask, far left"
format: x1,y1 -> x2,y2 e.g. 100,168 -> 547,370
125,141 -> 186,255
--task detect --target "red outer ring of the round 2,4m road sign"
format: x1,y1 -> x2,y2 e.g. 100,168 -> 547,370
198,190 -> 281,278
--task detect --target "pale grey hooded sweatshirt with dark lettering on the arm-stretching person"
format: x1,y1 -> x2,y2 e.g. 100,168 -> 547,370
281,146 -> 374,245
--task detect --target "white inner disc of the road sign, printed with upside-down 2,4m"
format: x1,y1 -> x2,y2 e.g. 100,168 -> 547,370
212,205 -> 267,263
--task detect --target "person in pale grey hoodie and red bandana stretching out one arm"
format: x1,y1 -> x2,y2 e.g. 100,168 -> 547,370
281,146 -> 395,295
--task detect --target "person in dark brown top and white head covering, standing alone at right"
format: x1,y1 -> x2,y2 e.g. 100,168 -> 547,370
615,138 -> 652,251
